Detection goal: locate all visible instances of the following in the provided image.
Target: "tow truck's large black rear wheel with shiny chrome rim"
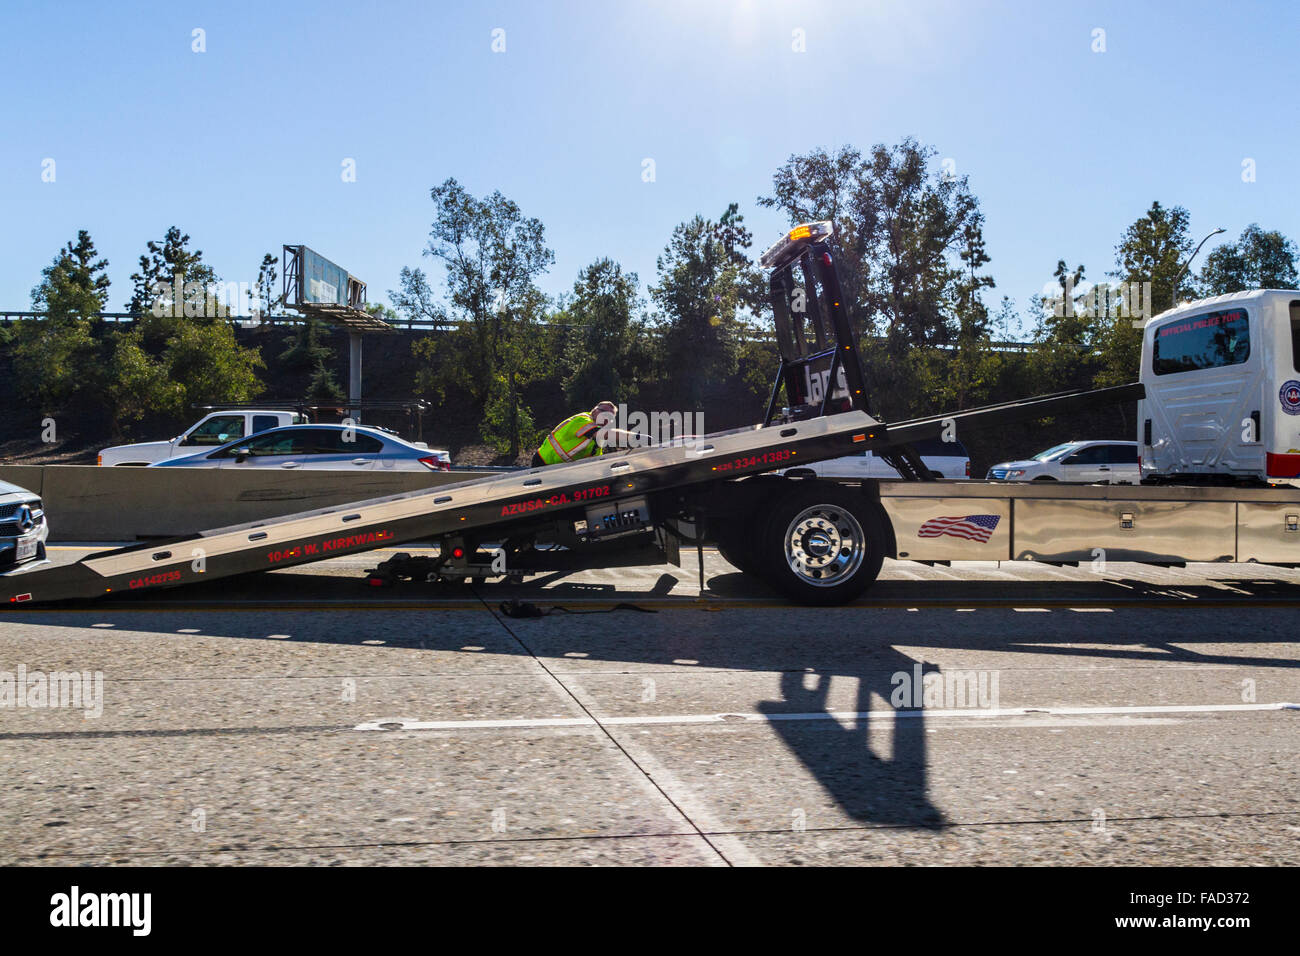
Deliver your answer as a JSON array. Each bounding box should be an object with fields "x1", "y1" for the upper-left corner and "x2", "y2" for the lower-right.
[{"x1": 754, "y1": 483, "x2": 887, "y2": 606}]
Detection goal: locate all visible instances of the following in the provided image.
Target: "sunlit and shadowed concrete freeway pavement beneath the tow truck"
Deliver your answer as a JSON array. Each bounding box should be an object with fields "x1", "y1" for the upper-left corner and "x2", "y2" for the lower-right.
[{"x1": 0, "y1": 550, "x2": 1300, "y2": 865}]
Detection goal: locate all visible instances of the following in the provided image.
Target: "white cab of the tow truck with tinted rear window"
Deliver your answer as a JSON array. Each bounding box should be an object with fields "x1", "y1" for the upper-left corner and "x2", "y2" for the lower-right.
[{"x1": 1138, "y1": 290, "x2": 1300, "y2": 480}]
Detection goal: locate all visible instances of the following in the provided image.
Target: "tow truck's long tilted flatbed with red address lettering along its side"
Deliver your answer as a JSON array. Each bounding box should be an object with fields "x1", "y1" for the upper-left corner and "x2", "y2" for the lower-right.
[{"x1": 0, "y1": 385, "x2": 1140, "y2": 605}]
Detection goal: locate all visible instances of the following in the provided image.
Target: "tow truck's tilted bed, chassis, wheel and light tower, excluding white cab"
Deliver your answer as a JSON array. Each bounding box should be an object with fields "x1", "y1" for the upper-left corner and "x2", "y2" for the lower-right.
[{"x1": 0, "y1": 222, "x2": 1300, "y2": 605}]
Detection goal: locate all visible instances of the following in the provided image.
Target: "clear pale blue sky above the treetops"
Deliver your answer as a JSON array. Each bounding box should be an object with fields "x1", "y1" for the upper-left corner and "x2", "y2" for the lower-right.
[{"x1": 0, "y1": 0, "x2": 1300, "y2": 335}]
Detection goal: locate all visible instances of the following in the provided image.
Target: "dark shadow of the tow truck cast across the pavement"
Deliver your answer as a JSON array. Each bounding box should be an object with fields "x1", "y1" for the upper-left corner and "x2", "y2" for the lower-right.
[{"x1": 0, "y1": 574, "x2": 1300, "y2": 827}]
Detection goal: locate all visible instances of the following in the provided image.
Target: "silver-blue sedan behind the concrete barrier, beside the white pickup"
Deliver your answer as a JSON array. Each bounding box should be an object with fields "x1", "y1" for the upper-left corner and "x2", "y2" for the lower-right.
[{"x1": 150, "y1": 425, "x2": 451, "y2": 471}]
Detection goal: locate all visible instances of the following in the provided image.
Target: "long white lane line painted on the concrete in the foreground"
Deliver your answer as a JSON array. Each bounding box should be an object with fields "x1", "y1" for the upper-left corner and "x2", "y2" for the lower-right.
[{"x1": 352, "y1": 702, "x2": 1300, "y2": 731}]
